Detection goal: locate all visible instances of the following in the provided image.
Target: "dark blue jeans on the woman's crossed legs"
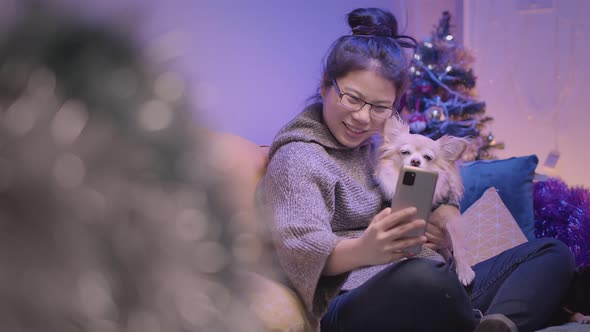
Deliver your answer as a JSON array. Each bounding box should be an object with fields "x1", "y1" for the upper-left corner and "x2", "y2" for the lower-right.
[{"x1": 321, "y1": 238, "x2": 575, "y2": 332}]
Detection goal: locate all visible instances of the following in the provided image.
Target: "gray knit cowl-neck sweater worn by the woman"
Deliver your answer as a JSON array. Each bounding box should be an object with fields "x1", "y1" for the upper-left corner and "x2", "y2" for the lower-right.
[{"x1": 258, "y1": 104, "x2": 442, "y2": 320}]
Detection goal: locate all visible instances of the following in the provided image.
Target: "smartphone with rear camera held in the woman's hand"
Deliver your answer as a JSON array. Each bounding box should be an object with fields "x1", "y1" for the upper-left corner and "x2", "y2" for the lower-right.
[{"x1": 391, "y1": 166, "x2": 438, "y2": 254}]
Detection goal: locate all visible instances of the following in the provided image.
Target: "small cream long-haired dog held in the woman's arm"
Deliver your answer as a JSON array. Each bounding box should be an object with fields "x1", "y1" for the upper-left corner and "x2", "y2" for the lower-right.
[{"x1": 375, "y1": 117, "x2": 475, "y2": 286}]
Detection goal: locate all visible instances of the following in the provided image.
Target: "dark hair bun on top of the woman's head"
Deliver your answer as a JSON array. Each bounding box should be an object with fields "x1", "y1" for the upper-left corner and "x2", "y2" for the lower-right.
[{"x1": 348, "y1": 8, "x2": 397, "y2": 37}]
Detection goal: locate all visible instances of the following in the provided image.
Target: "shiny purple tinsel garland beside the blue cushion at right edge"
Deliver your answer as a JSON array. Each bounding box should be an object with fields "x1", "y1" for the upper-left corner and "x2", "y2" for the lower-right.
[{"x1": 533, "y1": 178, "x2": 590, "y2": 266}]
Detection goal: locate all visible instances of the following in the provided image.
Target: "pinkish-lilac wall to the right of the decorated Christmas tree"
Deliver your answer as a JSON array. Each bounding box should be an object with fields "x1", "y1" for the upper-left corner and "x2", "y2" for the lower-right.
[{"x1": 464, "y1": 0, "x2": 590, "y2": 186}]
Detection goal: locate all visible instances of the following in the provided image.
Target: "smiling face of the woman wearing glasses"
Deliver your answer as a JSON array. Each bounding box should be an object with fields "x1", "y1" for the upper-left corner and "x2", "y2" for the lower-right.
[{"x1": 322, "y1": 70, "x2": 396, "y2": 148}]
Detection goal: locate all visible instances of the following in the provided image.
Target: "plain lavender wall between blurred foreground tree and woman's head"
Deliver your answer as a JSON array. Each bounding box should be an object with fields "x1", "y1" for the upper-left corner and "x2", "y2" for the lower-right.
[{"x1": 0, "y1": 0, "x2": 459, "y2": 144}]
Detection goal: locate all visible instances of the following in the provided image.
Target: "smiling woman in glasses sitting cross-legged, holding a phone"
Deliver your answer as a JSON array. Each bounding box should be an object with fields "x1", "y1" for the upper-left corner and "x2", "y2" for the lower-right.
[{"x1": 259, "y1": 8, "x2": 573, "y2": 332}]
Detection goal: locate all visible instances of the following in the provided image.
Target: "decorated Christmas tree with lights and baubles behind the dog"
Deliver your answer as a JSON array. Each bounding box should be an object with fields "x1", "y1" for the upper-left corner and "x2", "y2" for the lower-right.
[{"x1": 402, "y1": 11, "x2": 504, "y2": 160}]
